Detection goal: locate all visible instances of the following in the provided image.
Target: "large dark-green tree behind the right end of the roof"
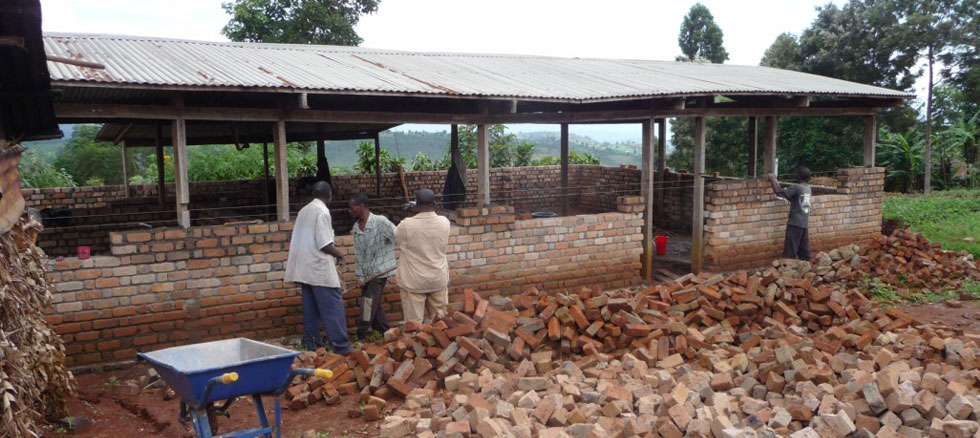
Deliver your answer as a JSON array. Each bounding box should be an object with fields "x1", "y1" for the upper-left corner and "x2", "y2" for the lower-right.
[{"x1": 760, "y1": 0, "x2": 918, "y2": 176}]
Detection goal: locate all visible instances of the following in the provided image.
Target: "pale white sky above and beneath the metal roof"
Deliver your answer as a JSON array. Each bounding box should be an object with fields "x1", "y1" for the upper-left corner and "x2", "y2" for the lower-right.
[{"x1": 41, "y1": 0, "x2": 843, "y2": 142}]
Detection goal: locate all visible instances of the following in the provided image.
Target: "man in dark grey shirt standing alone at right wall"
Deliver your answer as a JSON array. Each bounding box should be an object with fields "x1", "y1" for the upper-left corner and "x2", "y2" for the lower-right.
[{"x1": 769, "y1": 167, "x2": 812, "y2": 260}]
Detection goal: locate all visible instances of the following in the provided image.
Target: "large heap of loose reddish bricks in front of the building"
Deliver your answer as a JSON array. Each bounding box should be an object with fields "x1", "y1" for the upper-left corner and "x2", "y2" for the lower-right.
[{"x1": 289, "y1": 232, "x2": 980, "y2": 438}]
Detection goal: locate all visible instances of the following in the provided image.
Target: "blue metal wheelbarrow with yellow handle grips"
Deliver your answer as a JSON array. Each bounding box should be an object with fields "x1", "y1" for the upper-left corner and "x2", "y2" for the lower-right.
[{"x1": 138, "y1": 338, "x2": 333, "y2": 438}]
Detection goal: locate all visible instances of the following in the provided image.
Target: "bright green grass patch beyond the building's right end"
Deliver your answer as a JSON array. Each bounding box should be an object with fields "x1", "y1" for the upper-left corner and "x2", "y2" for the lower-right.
[{"x1": 882, "y1": 190, "x2": 980, "y2": 258}]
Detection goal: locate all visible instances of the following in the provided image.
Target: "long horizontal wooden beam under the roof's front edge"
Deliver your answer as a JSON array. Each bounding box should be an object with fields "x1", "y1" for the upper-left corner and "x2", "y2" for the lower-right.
[{"x1": 55, "y1": 103, "x2": 875, "y2": 125}]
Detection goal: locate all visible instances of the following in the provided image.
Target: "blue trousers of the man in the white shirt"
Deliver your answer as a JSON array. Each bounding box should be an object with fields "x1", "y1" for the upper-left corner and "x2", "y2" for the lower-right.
[{"x1": 300, "y1": 283, "x2": 352, "y2": 354}]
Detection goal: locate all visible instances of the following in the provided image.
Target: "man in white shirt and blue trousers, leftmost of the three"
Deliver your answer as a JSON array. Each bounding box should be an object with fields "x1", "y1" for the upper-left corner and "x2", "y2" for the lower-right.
[{"x1": 285, "y1": 181, "x2": 351, "y2": 354}]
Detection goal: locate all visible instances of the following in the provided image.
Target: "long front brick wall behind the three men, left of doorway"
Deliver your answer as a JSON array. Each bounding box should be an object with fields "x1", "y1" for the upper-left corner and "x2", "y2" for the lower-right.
[{"x1": 47, "y1": 197, "x2": 642, "y2": 366}]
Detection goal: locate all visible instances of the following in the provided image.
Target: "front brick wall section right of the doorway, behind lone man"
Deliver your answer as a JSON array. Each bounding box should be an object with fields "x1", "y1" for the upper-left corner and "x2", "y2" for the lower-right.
[{"x1": 704, "y1": 167, "x2": 885, "y2": 271}]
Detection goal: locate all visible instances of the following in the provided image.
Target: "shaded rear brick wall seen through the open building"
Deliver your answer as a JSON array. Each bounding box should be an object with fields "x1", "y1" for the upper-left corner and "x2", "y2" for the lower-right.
[{"x1": 24, "y1": 165, "x2": 644, "y2": 256}]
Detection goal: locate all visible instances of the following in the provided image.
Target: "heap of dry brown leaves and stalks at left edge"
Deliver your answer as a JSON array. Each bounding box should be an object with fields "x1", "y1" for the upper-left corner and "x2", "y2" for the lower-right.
[{"x1": 0, "y1": 216, "x2": 72, "y2": 437}]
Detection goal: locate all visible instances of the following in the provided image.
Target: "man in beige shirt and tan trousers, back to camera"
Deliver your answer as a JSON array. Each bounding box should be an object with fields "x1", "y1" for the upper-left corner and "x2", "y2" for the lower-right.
[{"x1": 395, "y1": 189, "x2": 450, "y2": 323}]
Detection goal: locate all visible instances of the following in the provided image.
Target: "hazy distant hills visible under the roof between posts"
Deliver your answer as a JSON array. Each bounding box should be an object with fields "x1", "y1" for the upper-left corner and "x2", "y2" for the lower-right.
[{"x1": 327, "y1": 131, "x2": 640, "y2": 167}]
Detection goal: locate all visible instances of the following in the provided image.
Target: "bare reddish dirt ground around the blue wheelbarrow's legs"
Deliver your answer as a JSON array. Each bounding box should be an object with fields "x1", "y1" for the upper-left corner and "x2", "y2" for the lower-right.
[{"x1": 42, "y1": 365, "x2": 393, "y2": 438}]
